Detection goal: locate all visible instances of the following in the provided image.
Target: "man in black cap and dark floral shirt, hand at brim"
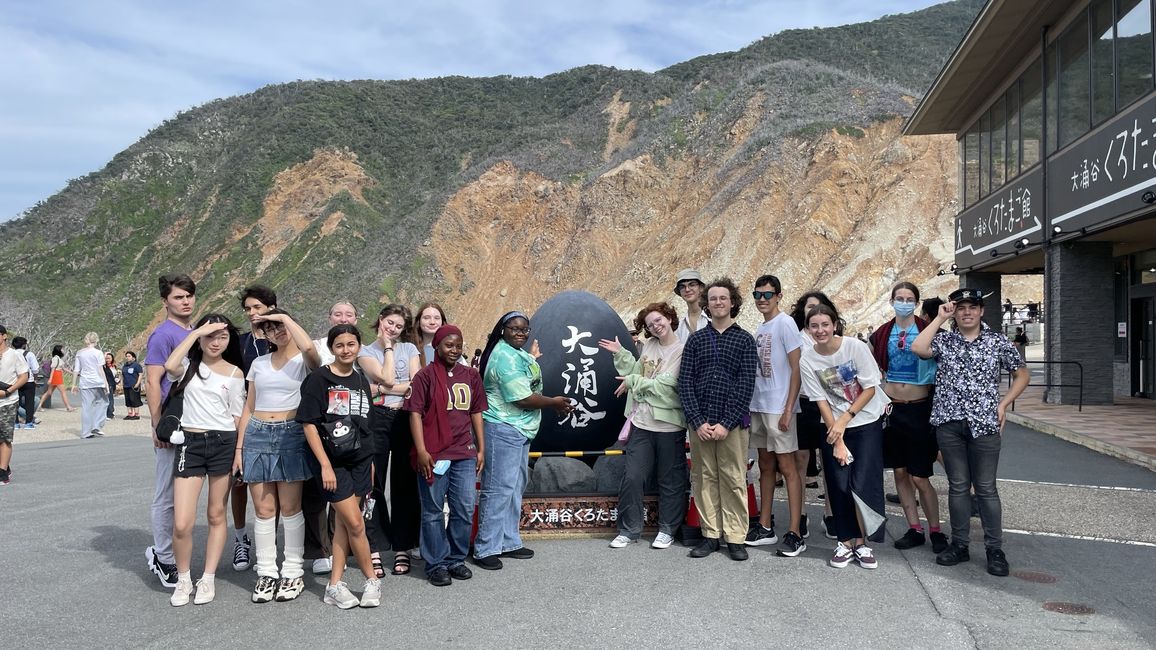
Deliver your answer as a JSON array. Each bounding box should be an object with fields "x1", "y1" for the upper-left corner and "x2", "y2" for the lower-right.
[{"x1": 911, "y1": 289, "x2": 1031, "y2": 576}]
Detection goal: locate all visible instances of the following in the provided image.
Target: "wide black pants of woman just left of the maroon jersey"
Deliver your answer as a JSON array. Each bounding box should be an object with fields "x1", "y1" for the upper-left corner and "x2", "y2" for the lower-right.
[{"x1": 365, "y1": 406, "x2": 422, "y2": 553}]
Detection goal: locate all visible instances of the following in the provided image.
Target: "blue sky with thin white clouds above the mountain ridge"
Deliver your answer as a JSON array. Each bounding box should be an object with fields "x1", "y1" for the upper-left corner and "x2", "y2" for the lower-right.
[{"x1": 0, "y1": 0, "x2": 936, "y2": 221}]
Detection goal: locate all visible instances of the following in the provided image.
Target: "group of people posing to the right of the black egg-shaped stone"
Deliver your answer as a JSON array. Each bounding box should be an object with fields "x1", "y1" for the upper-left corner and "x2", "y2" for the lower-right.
[{"x1": 600, "y1": 269, "x2": 1030, "y2": 576}]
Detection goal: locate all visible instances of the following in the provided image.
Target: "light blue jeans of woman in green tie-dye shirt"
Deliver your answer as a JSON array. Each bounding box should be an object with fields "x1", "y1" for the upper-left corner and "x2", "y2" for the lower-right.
[{"x1": 471, "y1": 421, "x2": 529, "y2": 559}]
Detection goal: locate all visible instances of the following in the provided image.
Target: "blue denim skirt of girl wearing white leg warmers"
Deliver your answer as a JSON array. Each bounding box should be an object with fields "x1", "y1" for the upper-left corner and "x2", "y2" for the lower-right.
[{"x1": 240, "y1": 418, "x2": 313, "y2": 483}]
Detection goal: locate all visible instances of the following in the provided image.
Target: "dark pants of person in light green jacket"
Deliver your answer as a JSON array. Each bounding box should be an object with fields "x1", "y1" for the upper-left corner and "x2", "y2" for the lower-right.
[{"x1": 618, "y1": 424, "x2": 689, "y2": 539}]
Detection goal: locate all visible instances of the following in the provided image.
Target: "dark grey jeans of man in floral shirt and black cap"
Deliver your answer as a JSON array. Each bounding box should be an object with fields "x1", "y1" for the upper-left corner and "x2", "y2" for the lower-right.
[{"x1": 935, "y1": 420, "x2": 1003, "y2": 548}]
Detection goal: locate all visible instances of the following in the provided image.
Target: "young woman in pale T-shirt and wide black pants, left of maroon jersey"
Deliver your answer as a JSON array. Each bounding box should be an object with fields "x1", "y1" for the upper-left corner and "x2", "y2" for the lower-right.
[{"x1": 357, "y1": 304, "x2": 425, "y2": 577}]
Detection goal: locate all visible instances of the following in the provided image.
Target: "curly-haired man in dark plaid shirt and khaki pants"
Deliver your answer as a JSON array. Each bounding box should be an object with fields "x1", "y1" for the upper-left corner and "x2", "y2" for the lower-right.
[{"x1": 679, "y1": 278, "x2": 758, "y2": 561}]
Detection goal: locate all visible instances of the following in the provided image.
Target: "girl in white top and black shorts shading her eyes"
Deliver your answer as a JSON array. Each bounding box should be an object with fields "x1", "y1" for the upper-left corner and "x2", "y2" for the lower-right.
[{"x1": 164, "y1": 313, "x2": 245, "y2": 606}]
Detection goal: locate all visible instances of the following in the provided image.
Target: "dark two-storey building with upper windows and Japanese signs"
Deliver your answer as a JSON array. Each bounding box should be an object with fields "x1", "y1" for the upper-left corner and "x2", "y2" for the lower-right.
[{"x1": 905, "y1": 0, "x2": 1156, "y2": 404}]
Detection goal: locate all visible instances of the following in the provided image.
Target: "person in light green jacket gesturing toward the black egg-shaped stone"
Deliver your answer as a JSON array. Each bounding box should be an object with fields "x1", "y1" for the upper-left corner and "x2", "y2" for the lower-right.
[{"x1": 598, "y1": 303, "x2": 689, "y2": 548}]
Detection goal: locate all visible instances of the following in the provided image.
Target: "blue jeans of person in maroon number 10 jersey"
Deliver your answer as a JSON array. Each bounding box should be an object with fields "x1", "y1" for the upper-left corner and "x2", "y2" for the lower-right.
[{"x1": 417, "y1": 458, "x2": 477, "y2": 575}]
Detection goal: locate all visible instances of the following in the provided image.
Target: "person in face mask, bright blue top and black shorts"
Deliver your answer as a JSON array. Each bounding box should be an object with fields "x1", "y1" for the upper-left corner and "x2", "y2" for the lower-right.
[{"x1": 870, "y1": 282, "x2": 947, "y2": 553}]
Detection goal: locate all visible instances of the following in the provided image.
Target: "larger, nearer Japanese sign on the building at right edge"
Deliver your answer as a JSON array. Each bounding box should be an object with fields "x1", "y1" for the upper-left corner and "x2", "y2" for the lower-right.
[{"x1": 1047, "y1": 91, "x2": 1156, "y2": 232}]
